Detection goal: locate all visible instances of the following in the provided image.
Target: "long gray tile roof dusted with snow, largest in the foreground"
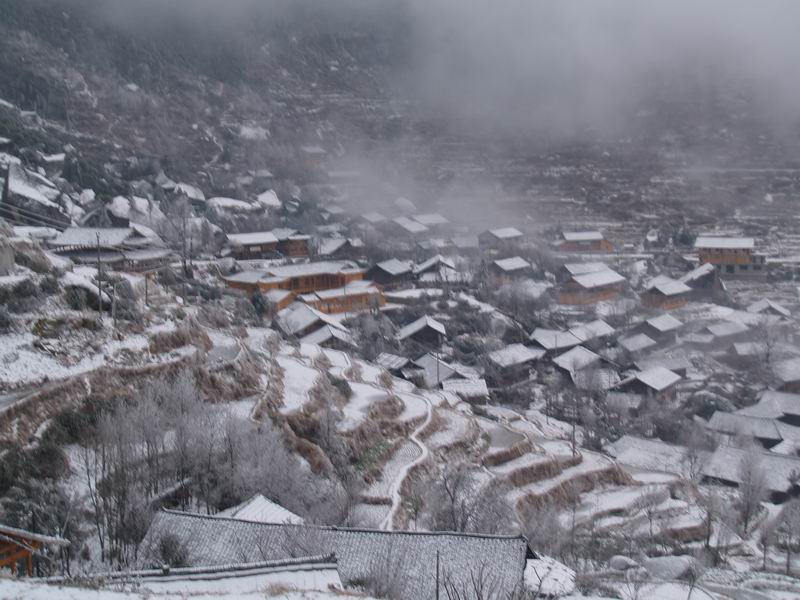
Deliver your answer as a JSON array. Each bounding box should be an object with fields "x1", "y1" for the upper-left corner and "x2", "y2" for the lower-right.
[{"x1": 141, "y1": 510, "x2": 529, "y2": 600}]
